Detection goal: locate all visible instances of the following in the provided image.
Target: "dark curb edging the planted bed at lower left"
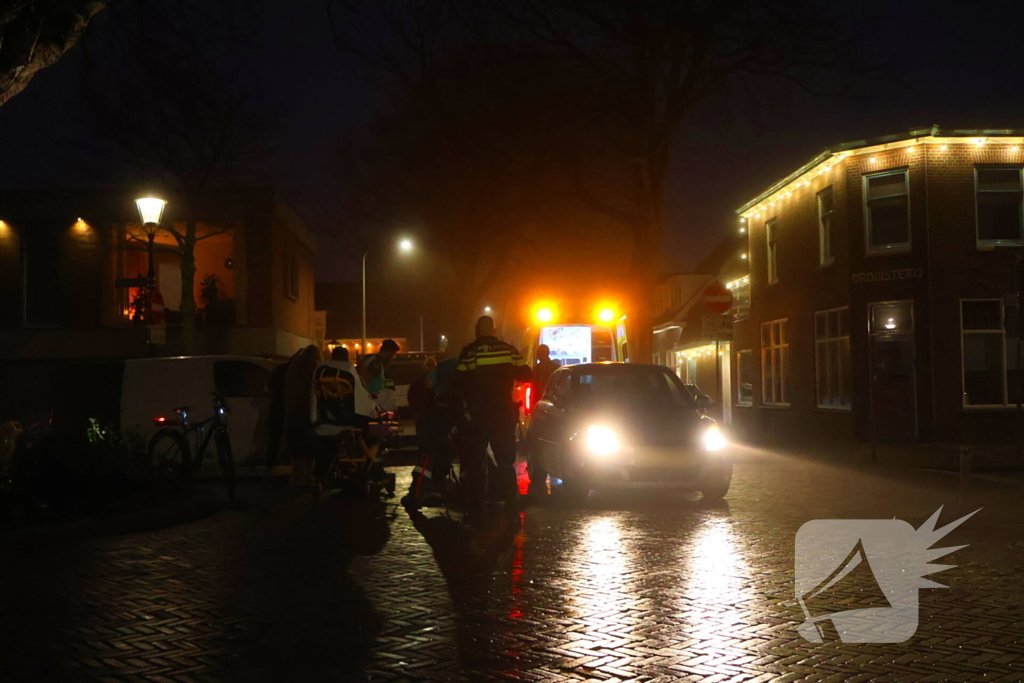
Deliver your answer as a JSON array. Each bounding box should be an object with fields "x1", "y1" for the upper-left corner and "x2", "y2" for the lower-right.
[{"x1": 0, "y1": 488, "x2": 222, "y2": 548}]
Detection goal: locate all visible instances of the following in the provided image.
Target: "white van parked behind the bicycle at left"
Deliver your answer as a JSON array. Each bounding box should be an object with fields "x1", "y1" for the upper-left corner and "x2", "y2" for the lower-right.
[{"x1": 120, "y1": 355, "x2": 274, "y2": 467}]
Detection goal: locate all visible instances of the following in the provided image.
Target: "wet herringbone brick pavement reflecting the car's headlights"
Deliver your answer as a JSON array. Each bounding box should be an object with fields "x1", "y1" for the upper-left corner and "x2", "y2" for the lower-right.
[{"x1": 0, "y1": 450, "x2": 1024, "y2": 681}]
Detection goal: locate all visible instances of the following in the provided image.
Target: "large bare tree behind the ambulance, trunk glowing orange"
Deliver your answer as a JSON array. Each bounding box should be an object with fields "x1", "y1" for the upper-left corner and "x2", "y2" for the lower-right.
[{"x1": 330, "y1": 0, "x2": 863, "y2": 359}]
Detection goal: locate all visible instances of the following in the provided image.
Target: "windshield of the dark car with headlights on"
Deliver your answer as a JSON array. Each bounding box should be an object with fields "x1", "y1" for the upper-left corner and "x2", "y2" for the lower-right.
[{"x1": 572, "y1": 366, "x2": 694, "y2": 410}]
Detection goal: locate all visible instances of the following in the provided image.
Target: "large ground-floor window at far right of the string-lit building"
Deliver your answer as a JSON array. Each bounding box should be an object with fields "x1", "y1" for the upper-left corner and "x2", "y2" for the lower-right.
[{"x1": 961, "y1": 299, "x2": 1020, "y2": 407}]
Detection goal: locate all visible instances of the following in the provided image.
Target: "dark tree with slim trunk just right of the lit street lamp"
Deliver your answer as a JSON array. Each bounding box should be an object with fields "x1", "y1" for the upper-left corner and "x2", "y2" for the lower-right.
[{"x1": 77, "y1": 0, "x2": 272, "y2": 348}]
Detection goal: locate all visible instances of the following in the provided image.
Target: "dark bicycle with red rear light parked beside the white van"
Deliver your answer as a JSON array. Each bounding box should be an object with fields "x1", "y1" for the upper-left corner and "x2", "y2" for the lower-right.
[{"x1": 147, "y1": 391, "x2": 234, "y2": 500}]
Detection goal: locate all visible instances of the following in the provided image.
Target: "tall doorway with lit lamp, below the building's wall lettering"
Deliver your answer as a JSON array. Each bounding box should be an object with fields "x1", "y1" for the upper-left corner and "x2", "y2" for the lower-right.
[{"x1": 868, "y1": 301, "x2": 918, "y2": 441}]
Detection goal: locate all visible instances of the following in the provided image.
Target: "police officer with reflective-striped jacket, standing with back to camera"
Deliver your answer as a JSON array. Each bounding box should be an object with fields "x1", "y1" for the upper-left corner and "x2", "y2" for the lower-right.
[{"x1": 455, "y1": 315, "x2": 531, "y2": 515}]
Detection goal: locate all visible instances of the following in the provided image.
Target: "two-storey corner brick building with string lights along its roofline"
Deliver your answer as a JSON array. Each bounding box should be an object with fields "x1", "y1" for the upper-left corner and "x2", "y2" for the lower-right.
[{"x1": 732, "y1": 127, "x2": 1024, "y2": 442}]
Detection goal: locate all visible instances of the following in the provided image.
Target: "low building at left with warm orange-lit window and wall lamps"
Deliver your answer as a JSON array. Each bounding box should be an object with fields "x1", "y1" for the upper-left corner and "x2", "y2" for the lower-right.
[{"x1": 0, "y1": 187, "x2": 316, "y2": 358}]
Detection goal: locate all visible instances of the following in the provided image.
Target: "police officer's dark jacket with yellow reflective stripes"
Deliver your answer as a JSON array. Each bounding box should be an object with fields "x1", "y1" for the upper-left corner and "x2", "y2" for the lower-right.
[{"x1": 455, "y1": 337, "x2": 531, "y2": 414}]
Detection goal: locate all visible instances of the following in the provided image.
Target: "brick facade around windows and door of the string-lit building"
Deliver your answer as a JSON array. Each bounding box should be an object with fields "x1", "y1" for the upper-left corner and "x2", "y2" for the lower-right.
[{"x1": 733, "y1": 143, "x2": 1024, "y2": 442}]
